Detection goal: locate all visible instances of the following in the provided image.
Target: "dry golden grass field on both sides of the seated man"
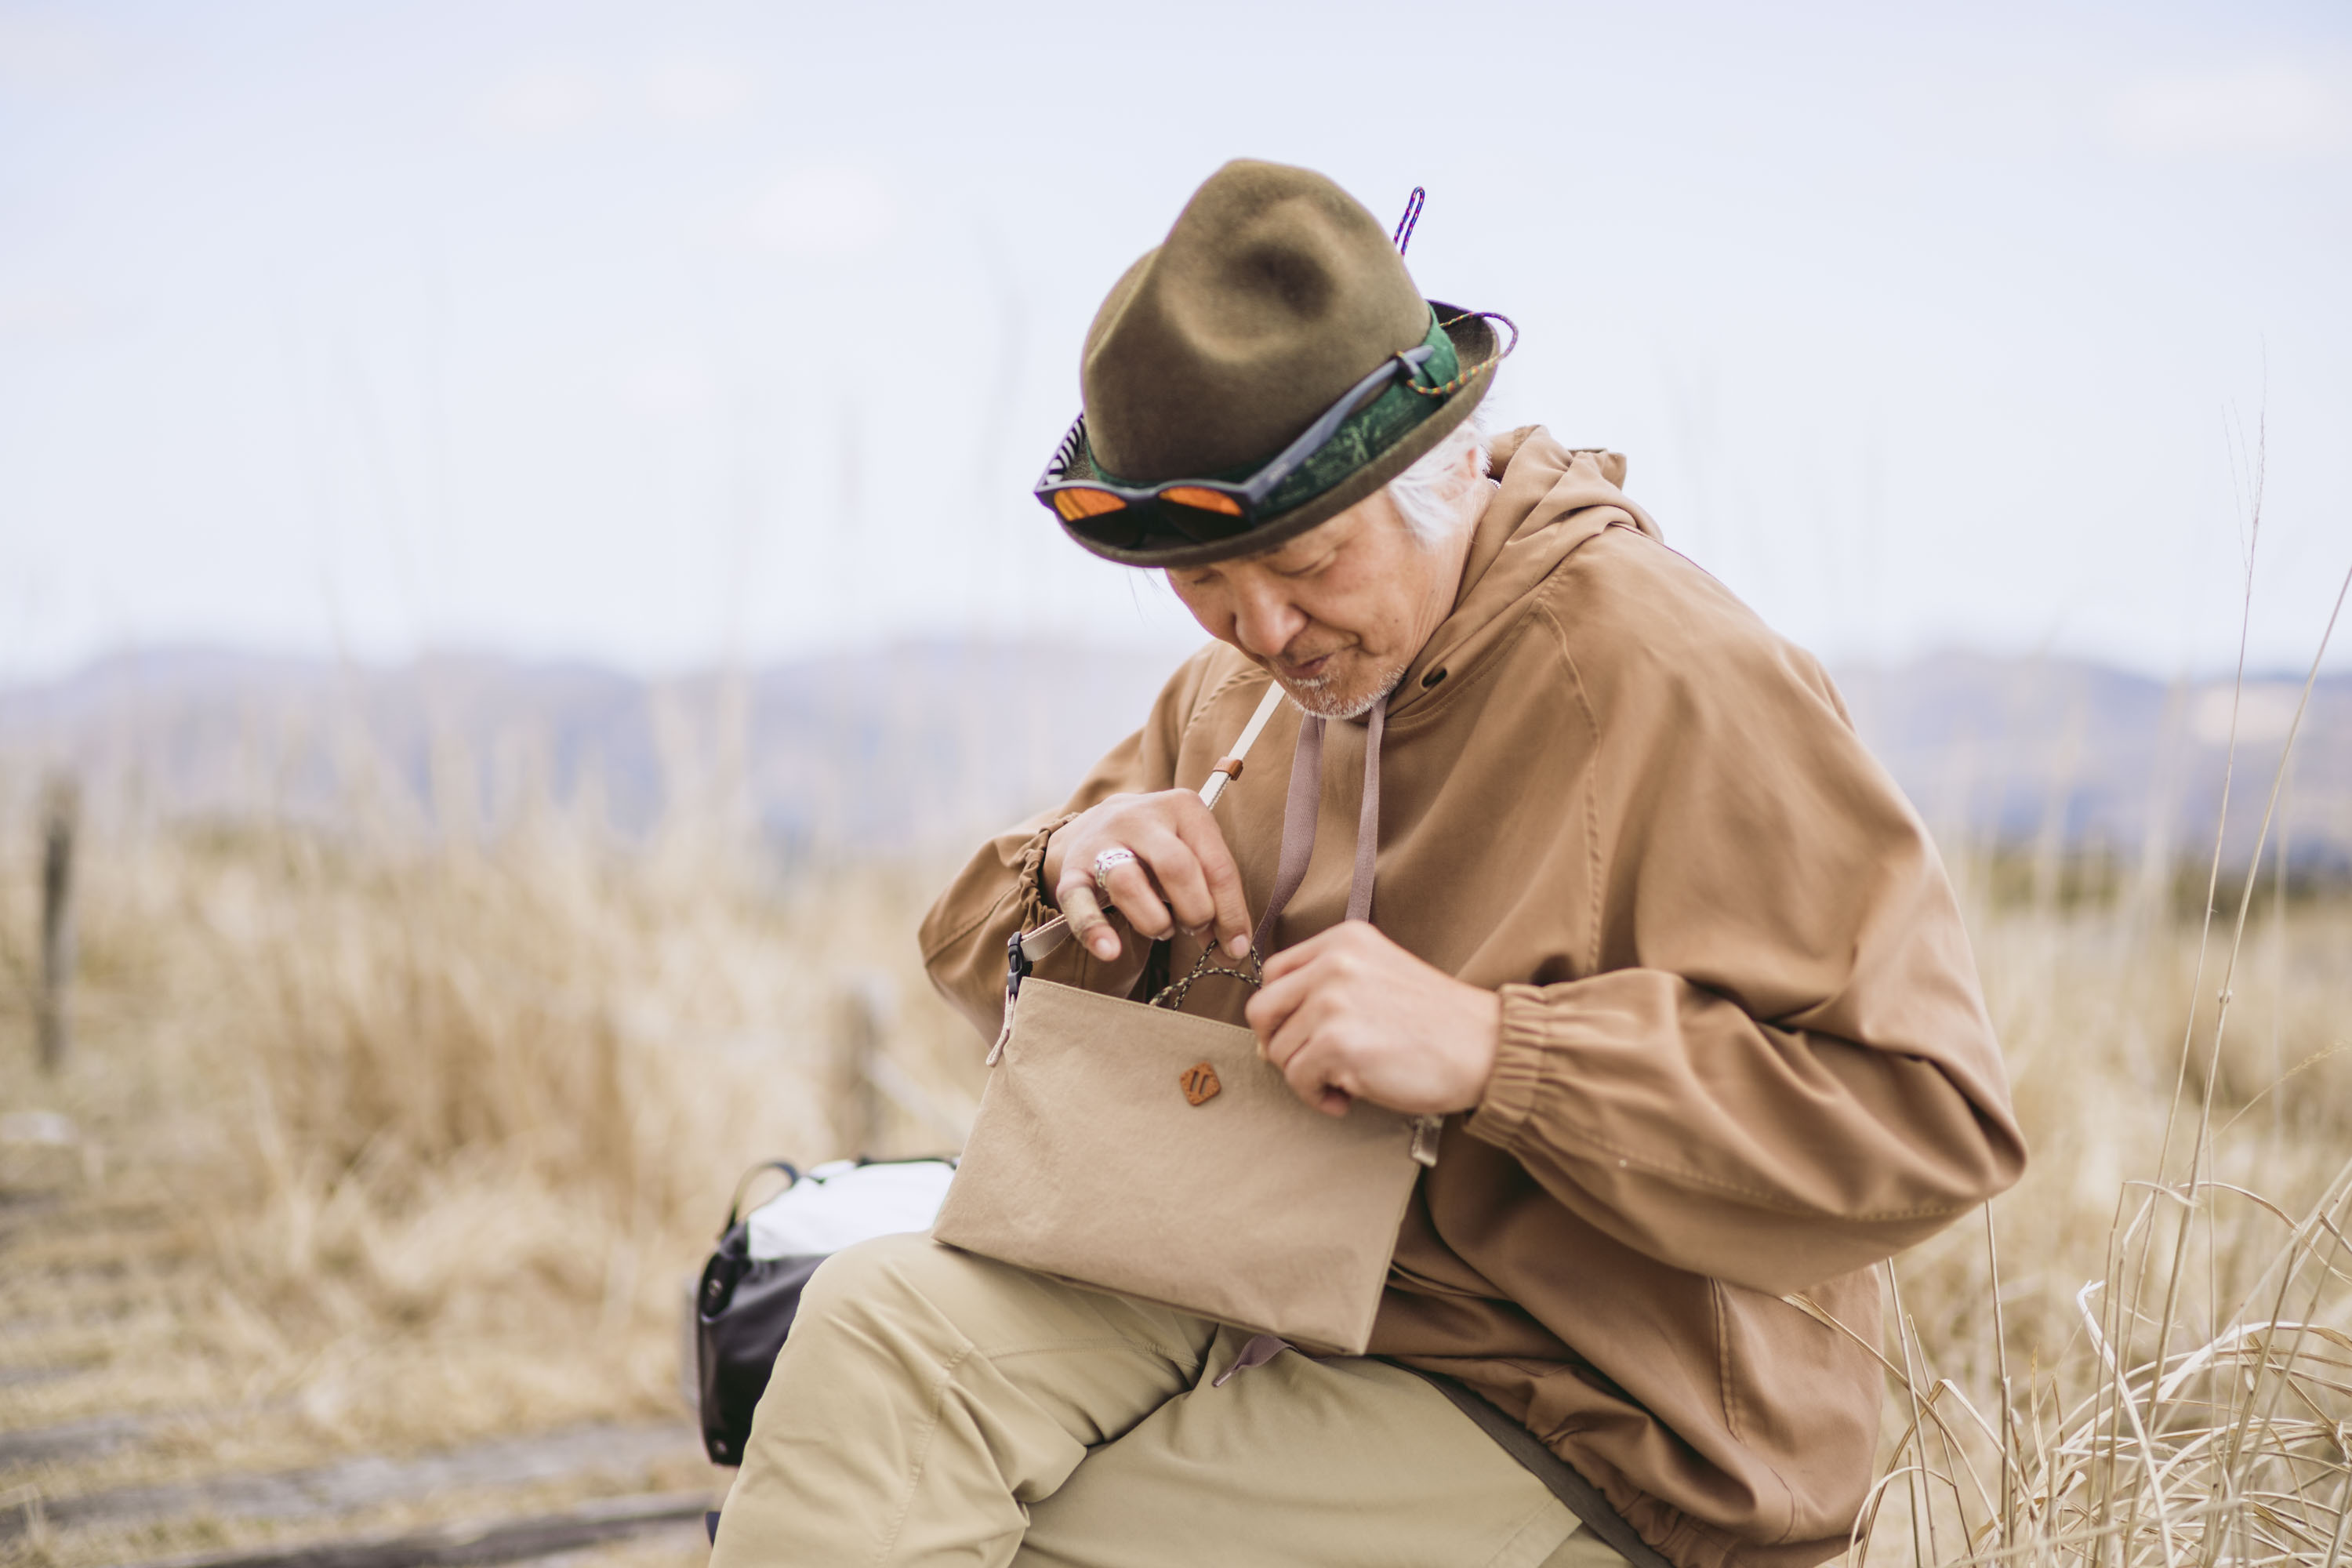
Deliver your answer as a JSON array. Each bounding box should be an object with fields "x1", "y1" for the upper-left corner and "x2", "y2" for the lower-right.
[{"x1": 0, "y1": 738, "x2": 2352, "y2": 1568}]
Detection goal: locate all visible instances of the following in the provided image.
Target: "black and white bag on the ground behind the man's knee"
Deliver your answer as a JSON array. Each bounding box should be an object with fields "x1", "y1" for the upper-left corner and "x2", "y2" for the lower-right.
[{"x1": 694, "y1": 1159, "x2": 955, "y2": 1465}]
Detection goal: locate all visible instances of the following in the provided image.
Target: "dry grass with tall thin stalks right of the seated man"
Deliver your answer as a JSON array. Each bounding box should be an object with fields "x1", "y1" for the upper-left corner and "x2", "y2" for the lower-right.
[{"x1": 1856, "y1": 533, "x2": 2352, "y2": 1568}]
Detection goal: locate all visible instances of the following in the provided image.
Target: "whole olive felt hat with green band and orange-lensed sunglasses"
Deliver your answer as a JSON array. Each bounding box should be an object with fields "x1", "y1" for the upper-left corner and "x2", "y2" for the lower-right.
[{"x1": 1037, "y1": 160, "x2": 1508, "y2": 567}]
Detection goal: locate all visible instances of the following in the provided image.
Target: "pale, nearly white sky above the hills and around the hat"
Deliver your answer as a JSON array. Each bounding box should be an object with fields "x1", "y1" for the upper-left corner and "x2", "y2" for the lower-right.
[{"x1": 0, "y1": 0, "x2": 2352, "y2": 682}]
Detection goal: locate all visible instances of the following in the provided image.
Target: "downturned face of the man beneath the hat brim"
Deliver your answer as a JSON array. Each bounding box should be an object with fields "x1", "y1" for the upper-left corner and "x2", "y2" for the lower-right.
[{"x1": 1169, "y1": 492, "x2": 1470, "y2": 720}]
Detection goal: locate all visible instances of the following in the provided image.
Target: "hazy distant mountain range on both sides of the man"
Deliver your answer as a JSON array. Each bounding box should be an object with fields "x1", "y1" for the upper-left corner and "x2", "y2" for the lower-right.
[{"x1": 0, "y1": 642, "x2": 2352, "y2": 869}]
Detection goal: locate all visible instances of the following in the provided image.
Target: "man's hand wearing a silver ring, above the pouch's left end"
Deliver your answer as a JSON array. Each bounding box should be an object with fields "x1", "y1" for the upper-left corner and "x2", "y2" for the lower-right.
[{"x1": 1042, "y1": 789, "x2": 1249, "y2": 961}]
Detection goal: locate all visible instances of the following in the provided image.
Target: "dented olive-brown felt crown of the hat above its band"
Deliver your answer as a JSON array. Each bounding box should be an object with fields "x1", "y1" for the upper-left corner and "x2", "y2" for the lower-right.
[{"x1": 1080, "y1": 160, "x2": 1430, "y2": 485}]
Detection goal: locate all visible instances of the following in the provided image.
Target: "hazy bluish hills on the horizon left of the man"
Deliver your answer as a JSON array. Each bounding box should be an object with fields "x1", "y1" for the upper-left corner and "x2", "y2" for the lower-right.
[{"x1": 0, "y1": 642, "x2": 1169, "y2": 862}]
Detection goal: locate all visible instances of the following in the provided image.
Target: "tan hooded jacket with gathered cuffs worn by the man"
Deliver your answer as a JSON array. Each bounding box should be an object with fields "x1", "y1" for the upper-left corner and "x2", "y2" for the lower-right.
[{"x1": 922, "y1": 428, "x2": 2025, "y2": 1568}]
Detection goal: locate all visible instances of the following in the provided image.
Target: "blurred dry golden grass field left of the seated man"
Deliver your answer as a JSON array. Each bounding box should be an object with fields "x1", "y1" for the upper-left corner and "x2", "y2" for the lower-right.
[{"x1": 0, "y1": 820, "x2": 978, "y2": 1563}]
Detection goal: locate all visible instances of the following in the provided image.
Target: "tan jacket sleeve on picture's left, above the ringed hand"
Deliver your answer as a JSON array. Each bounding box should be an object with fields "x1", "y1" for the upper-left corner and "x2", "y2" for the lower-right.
[{"x1": 920, "y1": 647, "x2": 1216, "y2": 1039}]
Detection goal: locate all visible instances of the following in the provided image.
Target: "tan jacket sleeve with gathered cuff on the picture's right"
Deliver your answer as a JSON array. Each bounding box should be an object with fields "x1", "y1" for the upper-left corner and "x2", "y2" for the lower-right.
[{"x1": 1468, "y1": 583, "x2": 2025, "y2": 1293}]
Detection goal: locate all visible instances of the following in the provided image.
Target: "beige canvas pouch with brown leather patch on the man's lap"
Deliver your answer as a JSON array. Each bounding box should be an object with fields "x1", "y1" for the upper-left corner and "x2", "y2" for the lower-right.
[{"x1": 931, "y1": 687, "x2": 1439, "y2": 1354}]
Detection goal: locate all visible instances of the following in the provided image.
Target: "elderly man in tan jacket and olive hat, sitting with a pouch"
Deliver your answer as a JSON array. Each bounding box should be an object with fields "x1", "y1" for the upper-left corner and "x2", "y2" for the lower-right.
[{"x1": 715, "y1": 162, "x2": 2025, "y2": 1568}]
